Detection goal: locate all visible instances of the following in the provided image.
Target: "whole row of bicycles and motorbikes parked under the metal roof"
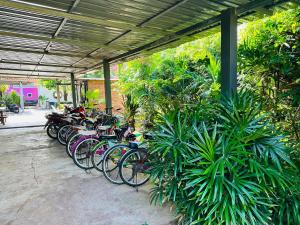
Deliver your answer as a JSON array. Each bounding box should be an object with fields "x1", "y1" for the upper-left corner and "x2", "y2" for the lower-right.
[{"x1": 45, "y1": 106, "x2": 151, "y2": 187}]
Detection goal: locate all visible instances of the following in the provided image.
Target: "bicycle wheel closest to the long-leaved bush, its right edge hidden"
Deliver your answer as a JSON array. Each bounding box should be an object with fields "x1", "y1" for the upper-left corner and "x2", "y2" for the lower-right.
[{"x1": 119, "y1": 149, "x2": 150, "y2": 187}]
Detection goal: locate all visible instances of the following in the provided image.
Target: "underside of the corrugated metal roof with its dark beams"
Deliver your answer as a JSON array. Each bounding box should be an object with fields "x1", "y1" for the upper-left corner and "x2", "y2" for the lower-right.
[{"x1": 0, "y1": 0, "x2": 299, "y2": 79}]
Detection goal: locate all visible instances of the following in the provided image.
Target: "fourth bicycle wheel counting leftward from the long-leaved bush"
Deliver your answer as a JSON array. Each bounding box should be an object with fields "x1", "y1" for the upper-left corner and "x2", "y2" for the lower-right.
[{"x1": 72, "y1": 138, "x2": 100, "y2": 169}]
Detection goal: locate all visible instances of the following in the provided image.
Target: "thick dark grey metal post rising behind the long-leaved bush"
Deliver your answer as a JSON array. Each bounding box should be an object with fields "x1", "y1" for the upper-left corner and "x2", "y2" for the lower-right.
[{"x1": 221, "y1": 8, "x2": 237, "y2": 97}]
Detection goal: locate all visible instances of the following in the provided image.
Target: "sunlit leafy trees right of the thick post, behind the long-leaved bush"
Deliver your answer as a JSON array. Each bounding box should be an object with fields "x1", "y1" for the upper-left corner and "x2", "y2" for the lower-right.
[{"x1": 239, "y1": 8, "x2": 300, "y2": 168}]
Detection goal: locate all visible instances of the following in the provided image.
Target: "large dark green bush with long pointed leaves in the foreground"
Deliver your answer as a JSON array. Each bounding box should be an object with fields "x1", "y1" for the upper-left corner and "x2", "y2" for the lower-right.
[{"x1": 151, "y1": 91, "x2": 300, "y2": 225}]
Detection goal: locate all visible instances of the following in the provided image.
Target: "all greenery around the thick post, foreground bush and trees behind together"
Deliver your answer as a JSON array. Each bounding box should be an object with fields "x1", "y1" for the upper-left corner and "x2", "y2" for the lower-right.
[{"x1": 113, "y1": 8, "x2": 300, "y2": 225}]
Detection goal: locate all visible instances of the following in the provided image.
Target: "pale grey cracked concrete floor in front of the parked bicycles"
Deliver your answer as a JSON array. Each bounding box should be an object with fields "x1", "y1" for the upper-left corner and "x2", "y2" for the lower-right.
[{"x1": 0, "y1": 128, "x2": 174, "y2": 225}]
